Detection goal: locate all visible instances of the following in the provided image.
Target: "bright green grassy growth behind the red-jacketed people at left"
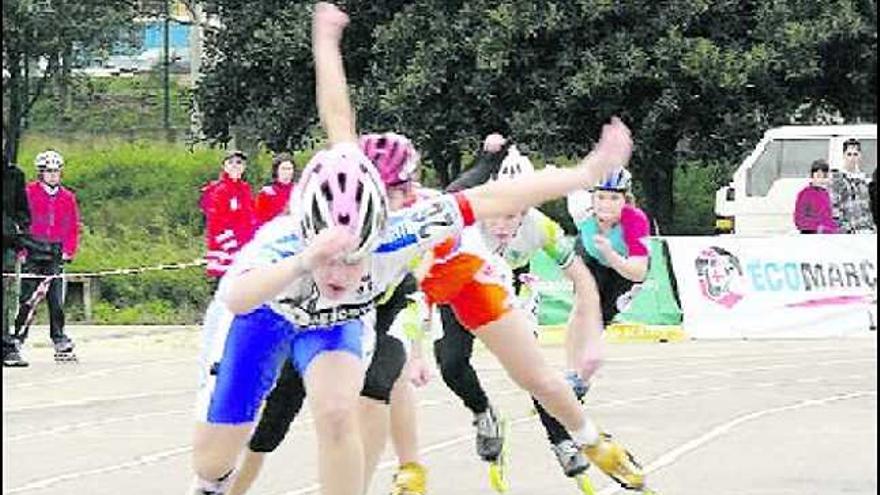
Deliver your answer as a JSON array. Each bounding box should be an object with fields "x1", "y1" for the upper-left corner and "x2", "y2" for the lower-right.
[{"x1": 20, "y1": 135, "x2": 268, "y2": 324}]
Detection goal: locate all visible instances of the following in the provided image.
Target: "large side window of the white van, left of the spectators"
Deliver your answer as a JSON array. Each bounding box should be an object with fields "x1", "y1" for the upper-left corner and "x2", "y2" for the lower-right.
[{"x1": 746, "y1": 139, "x2": 828, "y2": 196}]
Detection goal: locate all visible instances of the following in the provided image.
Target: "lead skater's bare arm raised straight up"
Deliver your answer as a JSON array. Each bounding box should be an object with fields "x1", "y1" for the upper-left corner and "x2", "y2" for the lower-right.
[{"x1": 312, "y1": 2, "x2": 357, "y2": 146}]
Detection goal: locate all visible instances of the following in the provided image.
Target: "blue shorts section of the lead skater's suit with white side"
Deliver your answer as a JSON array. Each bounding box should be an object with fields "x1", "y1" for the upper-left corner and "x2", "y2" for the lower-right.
[{"x1": 197, "y1": 306, "x2": 364, "y2": 424}]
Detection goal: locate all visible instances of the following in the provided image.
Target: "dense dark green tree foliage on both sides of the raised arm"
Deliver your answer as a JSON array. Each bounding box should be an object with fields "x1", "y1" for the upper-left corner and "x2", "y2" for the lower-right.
[{"x1": 197, "y1": 0, "x2": 877, "y2": 229}]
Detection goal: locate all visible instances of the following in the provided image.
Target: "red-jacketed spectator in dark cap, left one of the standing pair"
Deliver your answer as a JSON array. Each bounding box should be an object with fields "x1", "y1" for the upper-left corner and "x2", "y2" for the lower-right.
[{"x1": 200, "y1": 150, "x2": 256, "y2": 280}]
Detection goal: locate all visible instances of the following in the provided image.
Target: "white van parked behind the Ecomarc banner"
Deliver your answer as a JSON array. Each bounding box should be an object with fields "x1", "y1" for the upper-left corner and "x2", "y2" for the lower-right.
[{"x1": 715, "y1": 124, "x2": 877, "y2": 236}]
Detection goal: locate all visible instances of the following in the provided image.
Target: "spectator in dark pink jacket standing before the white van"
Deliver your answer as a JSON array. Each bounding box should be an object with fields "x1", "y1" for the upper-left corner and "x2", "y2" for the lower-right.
[{"x1": 794, "y1": 159, "x2": 840, "y2": 234}]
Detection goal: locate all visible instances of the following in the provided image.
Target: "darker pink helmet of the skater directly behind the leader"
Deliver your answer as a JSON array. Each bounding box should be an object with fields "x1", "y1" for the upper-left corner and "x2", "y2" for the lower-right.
[{"x1": 360, "y1": 132, "x2": 419, "y2": 186}]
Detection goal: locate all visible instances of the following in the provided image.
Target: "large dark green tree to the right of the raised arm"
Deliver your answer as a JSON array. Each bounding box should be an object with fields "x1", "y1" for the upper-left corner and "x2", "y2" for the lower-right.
[{"x1": 361, "y1": 0, "x2": 876, "y2": 229}]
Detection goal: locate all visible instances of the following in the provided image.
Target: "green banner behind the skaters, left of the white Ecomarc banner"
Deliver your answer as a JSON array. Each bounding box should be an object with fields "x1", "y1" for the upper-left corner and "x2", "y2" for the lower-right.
[{"x1": 530, "y1": 239, "x2": 681, "y2": 325}]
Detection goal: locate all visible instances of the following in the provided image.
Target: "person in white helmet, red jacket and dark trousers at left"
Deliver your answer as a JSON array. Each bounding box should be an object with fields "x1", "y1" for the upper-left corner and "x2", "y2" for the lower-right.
[{"x1": 15, "y1": 150, "x2": 79, "y2": 360}]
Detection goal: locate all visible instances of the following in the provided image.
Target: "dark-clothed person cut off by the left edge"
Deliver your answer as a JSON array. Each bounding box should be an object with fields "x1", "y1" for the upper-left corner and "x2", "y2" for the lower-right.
[{"x1": 3, "y1": 149, "x2": 31, "y2": 366}]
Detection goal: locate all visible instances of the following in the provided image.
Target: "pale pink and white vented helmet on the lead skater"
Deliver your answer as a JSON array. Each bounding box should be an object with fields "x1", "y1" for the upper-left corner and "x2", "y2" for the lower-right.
[{"x1": 290, "y1": 144, "x2": 388, "y2": 259}]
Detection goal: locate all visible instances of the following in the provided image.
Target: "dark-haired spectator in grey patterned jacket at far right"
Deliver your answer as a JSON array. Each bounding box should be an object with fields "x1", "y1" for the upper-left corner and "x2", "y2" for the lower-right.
[{"x1": 830, "y1": 139, "x2": 876, "y2": 234}]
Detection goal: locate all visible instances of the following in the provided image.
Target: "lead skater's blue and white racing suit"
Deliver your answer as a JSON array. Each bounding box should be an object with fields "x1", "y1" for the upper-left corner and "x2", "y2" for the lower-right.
[{"x1": 196, "y1": 195, "x2": 473, "y2": 424}]
